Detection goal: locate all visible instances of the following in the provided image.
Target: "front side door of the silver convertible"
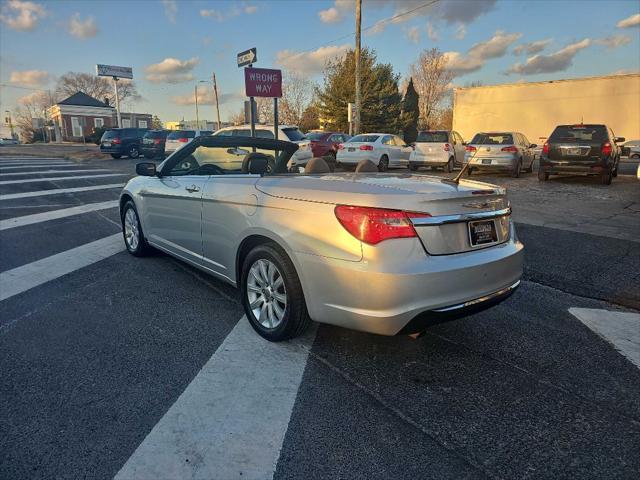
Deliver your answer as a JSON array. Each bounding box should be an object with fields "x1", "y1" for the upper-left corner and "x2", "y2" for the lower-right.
[{"x1": 141, "y1": 149, "x2": 209, "y2": 265}]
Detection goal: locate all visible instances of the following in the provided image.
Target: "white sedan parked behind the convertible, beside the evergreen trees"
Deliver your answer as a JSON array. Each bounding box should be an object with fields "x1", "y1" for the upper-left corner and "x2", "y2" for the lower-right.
[{"x1": 336, "y1": 133, "x2": 413, "y2": 172}]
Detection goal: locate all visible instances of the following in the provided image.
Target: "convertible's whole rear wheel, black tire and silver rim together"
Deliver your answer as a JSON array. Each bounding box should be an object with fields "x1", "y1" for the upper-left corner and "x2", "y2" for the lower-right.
[{"x1": 240, "y1": 243, "x2": 311, "y2": 342}]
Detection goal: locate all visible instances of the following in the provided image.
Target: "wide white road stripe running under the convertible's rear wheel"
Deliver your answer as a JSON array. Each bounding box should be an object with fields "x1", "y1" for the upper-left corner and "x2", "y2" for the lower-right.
[{"x1": 115, "y1": 317, "x2": 315, "y2": 480}]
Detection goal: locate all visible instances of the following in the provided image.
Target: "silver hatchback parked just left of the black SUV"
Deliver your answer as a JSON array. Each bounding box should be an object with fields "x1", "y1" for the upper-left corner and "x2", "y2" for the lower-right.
[{"x1": 465, "y1": 132, "x2": 537, "y2": 178}]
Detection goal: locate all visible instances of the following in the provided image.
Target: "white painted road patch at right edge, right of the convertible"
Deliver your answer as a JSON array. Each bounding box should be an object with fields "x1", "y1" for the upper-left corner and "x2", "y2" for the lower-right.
[{"x1": 569, "y1": 308, "x2": 640, "y2": 368}]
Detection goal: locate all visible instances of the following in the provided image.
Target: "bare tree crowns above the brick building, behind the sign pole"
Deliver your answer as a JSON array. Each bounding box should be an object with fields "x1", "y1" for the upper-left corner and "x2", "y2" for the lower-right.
[{"x1": 55, "y1": 72, "x2": 141, "y2": 105}]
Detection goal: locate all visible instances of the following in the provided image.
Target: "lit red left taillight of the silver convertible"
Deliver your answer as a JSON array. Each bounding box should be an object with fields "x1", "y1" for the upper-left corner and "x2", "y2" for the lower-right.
[{"x1": 335, "y1": 205, "x2": 431, "y2": 245}]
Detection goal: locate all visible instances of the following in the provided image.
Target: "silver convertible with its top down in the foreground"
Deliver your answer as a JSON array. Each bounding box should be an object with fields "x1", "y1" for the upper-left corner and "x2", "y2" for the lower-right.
[{"x1": 120, "y1": 137, "x2": 523, "y2": 341}]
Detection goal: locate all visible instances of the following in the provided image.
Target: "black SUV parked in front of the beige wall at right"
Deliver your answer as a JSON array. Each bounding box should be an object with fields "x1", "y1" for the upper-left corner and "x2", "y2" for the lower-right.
[{"x1": 538, "y1": 124, "x2": 624, "y2": 185}]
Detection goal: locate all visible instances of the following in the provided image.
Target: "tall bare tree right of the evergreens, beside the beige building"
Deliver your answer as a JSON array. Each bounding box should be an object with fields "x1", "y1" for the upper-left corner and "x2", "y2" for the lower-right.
[{"x1": 410, "y1": 48, "x2": 453, "y2": 128}]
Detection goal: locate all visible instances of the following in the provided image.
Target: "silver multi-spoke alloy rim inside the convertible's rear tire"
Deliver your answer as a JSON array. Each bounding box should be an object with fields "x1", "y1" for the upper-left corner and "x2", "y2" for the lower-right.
[{"x1": 246, "y1": 258, "x2": 287, "y2": 329}]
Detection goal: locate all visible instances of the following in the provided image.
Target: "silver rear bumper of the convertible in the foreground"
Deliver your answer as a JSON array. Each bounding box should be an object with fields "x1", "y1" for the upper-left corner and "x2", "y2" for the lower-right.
[{"x1": 298, "y1": 232, "x2": 523, "y2": 335}]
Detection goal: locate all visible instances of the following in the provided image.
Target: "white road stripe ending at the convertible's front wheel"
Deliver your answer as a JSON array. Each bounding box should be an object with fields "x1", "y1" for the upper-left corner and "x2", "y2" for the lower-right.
[{"x1": 0, "y1": 233, "x2": 124, "y2": 301}]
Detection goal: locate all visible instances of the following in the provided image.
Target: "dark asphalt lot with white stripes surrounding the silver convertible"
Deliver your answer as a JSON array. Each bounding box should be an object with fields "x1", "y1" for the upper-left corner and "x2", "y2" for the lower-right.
[{"x1": 0, "y1": 152, "x2": 640, "y2": 479}]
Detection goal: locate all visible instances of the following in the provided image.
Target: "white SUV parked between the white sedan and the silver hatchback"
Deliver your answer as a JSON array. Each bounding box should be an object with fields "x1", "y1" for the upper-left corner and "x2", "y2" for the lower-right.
[{"x1": 409, "y1": 130, "x2": 464, "y2": 172}]
